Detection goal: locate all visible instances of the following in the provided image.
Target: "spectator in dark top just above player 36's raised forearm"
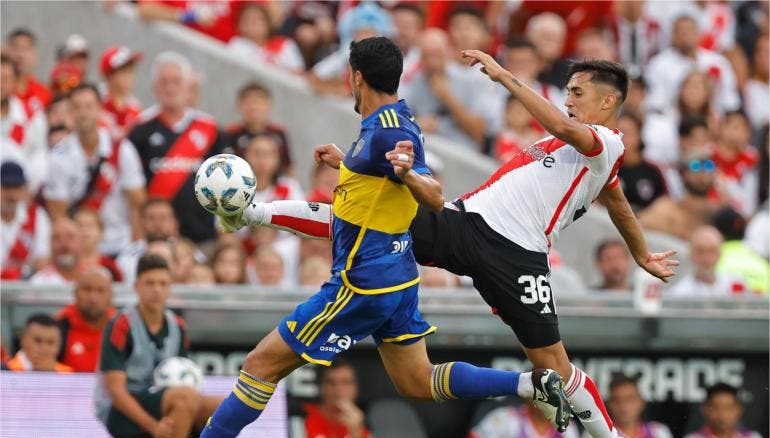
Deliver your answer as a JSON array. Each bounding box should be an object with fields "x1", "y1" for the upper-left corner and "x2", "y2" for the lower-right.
[{"x1": 524, "y1": 12, "x2": 569, "y2": 88}]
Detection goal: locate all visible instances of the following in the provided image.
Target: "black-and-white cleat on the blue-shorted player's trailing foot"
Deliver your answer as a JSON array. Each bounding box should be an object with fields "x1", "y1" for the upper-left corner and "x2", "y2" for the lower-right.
[{"x1": 532, "y1": 368, "x2": 572, "y2": 432}]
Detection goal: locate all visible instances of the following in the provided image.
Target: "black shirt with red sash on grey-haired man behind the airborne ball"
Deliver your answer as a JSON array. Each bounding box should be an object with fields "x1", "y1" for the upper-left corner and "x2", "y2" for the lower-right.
[{"x1": 127, "y1": 107, "x2": 224, "y2": 242}]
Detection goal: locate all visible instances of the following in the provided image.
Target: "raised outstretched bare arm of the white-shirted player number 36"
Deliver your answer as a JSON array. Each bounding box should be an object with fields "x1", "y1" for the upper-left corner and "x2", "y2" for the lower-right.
[{"x1": 461, "y1": 50, "x2": 596, "y2": 154}]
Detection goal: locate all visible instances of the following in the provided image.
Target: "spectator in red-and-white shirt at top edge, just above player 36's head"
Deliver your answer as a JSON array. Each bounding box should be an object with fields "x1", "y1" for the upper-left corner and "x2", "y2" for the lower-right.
[{"x1": 609, "y1": 1, "x2": 661, "y2": 78}]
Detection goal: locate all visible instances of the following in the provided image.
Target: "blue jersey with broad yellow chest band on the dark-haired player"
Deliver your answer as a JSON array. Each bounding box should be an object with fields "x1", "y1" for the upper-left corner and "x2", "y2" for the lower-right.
[{"x1": 332, "y1": 100, "x2": 430, "y2": 294}]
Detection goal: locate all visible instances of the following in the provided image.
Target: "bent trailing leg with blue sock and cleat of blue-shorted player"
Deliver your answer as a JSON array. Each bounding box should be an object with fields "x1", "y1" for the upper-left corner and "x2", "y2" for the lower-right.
[{"x1": 379, "y1": 339, "x2": 571, "y2": 432}]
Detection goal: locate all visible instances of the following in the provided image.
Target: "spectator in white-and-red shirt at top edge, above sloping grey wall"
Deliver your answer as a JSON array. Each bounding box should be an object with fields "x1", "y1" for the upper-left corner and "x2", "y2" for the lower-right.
[{"x1": 227, "y1": 3, "x2": 305, "y2": 73}]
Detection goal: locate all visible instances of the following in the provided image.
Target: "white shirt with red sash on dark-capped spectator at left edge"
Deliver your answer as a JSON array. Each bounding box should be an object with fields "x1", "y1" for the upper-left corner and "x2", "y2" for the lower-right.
[{"x1": 0, "y1": 203, "x2": 51, "y2": 280}]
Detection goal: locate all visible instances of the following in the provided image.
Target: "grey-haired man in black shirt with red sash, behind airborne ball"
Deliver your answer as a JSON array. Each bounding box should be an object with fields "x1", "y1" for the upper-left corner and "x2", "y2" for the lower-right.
[{"x1": 127, "y1": 52, "x2": 224, "y2": 244}]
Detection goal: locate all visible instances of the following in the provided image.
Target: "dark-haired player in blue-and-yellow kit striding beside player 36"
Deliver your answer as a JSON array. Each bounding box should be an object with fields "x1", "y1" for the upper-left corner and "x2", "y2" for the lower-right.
[{"x1": 201, "y1": 37, "x2": 571, "y2": 438}]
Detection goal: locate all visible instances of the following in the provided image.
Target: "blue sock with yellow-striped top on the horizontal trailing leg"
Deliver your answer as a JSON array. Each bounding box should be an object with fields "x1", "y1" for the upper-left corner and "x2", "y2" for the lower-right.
[{"x1": 431, "y1": 362, "x2": 521, "y2": 401}]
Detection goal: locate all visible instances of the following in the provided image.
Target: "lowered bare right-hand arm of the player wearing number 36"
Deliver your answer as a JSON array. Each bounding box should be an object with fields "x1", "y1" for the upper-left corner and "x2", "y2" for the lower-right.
[{"x1": 599, "y1": 184, "x2": 679, "y2": 282}]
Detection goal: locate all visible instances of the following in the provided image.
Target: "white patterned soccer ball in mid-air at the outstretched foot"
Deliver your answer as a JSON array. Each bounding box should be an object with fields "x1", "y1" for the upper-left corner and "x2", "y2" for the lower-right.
[{"x1": 195, "y1": 154, "x2": 256, "y2": 216}]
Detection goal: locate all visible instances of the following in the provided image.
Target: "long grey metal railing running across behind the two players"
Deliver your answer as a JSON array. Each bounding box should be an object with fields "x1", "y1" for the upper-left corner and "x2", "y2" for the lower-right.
[{"x1": 0, "y1": 282, "x2": 770, "y2": 353}]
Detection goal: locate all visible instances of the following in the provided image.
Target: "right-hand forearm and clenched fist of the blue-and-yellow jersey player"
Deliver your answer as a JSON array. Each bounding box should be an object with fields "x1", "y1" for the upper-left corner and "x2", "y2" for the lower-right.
[{"x1": 385, "y1": 140, "x2": 444, "y2": 211}]
